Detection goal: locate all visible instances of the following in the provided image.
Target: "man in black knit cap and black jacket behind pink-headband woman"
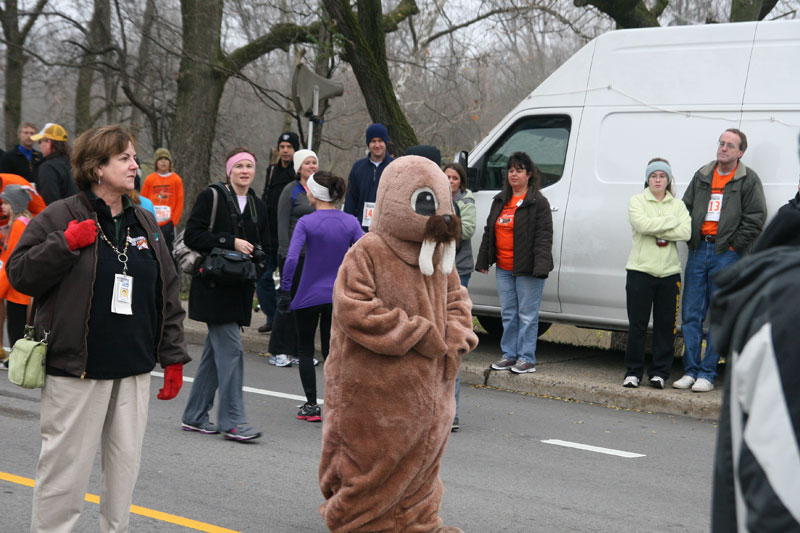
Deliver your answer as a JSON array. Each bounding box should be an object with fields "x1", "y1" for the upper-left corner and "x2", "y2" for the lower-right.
[{"x1": 256, "y1": 131, "x2": 300, "y2": 333}]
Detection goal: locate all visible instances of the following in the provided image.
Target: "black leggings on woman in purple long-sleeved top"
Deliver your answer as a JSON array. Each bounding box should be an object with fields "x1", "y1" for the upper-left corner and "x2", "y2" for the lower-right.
[{"x1": 294, "y1": 304, "x2": 333, "y2": 404}]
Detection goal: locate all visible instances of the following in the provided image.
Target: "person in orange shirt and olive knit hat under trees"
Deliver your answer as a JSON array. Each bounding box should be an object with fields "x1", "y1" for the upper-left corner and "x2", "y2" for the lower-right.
[{"x1": 141, "y1": 148, "x2": 183, "y2": 253}]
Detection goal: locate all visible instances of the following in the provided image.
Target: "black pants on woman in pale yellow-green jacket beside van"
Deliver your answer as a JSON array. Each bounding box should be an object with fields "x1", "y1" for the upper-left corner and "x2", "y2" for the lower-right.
[{"x1": 625, "y1": 270, "x2": 681, "y2": 381}]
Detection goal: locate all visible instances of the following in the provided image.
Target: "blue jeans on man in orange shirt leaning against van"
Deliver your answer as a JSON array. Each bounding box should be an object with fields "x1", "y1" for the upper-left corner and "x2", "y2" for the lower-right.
[{"x1": 681, "y1": 241, "x2": 739, "y2": 383}]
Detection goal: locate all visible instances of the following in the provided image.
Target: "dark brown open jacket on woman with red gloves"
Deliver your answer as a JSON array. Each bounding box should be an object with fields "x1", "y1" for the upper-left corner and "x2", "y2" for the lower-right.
[{"x1": 7, "y1": 192, "x2": 191, "y2": 377}]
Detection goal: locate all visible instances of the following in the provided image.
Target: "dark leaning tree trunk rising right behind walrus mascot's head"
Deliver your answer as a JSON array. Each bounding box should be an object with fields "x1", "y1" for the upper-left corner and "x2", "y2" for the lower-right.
[{"x1": 323, "y1": 0, "x2": 418, "y2": 154}]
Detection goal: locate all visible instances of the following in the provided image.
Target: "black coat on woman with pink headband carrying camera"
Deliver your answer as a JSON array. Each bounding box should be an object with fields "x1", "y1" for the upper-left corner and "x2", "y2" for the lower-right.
[{"x1": 184, "y1": 183, "x2": 269, "y2": 326}]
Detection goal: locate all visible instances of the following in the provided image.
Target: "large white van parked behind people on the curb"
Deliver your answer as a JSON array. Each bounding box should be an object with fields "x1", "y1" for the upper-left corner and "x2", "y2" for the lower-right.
[{"x1": 461, "y1": 21, "x2": 800, "y2": 332}]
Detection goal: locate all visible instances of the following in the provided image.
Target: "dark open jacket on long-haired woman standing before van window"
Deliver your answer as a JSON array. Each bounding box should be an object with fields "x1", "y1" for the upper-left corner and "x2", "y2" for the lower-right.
[{"x1": 475, "y1": 188, "x2": 553, "y2": 278}]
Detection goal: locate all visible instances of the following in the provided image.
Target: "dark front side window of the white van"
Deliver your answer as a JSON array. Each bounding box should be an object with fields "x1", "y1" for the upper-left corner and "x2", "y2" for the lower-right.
[{"x1": 473, "y1": 115, "x2": 572, "y2": 190}]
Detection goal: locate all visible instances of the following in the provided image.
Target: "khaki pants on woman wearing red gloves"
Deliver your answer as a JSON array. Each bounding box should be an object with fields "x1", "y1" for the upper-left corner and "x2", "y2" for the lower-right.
[{"x1": 31, "y1": 373, "x2": 150, "y2": 533}]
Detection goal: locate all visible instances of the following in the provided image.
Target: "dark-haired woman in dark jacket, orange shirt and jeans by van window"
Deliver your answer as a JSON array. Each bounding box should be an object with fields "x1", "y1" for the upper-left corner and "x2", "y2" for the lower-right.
[{"x1": 475, "y1": 152, "x2": 553, "y2": 374}]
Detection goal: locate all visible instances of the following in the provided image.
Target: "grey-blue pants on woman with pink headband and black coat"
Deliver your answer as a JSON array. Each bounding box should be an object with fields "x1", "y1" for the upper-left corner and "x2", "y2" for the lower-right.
[{"x1": 181, "y1": 322, "x2": 246, "y2": 431}]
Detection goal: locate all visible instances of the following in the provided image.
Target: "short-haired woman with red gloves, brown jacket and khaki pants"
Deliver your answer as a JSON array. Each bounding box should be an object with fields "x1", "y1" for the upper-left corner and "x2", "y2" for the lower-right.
[{"x1": 8, "y1": 126, "x2": 189, "y2": 531}]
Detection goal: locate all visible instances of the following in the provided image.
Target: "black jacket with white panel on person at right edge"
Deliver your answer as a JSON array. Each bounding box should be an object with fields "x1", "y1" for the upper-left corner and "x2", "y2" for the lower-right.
[{"x1": 709, "y1": 198, "x2": 800, "y2": 533}]
